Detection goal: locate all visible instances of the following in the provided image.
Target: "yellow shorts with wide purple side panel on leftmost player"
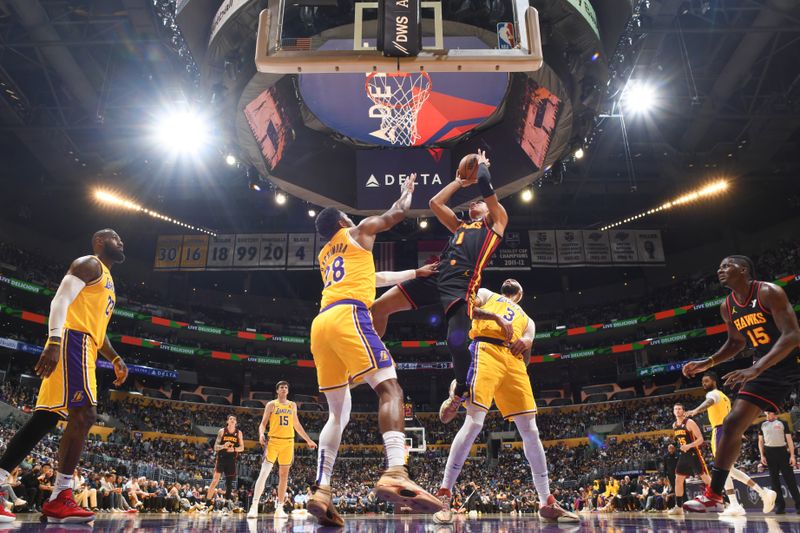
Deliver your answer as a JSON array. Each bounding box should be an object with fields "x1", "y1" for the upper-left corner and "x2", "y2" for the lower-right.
[{"x1": 36, "y1": 329, "x2": 97, "y2": 418}]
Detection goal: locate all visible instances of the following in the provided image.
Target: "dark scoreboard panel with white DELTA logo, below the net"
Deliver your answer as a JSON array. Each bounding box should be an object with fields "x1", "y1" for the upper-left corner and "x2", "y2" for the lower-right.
[{"x1": 356, "y1": 149, "x2": 453, "y2": 210}]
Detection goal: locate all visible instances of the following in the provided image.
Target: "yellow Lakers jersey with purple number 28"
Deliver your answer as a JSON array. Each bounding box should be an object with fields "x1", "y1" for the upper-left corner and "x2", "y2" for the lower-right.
[{"x1": 319, "y1": 228, "x2": 375, "y2": 308}]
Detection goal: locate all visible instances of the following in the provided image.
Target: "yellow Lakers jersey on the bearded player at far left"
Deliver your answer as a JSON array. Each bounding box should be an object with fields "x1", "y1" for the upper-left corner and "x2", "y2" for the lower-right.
[{"x1": 64, "y1": 259, "x2": 117, "y2": 347}]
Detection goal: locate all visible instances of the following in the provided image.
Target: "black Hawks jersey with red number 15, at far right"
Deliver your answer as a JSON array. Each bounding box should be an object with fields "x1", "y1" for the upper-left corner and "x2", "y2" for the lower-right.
[{"x1": 725, "y1": 281, "x2": 800, "y2": 367}]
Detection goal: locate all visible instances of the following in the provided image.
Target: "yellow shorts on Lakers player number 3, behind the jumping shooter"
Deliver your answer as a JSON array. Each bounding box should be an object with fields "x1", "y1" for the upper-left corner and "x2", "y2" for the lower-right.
[{"x1": 467, "y1": 341, "x2": 536, "y2": 418}]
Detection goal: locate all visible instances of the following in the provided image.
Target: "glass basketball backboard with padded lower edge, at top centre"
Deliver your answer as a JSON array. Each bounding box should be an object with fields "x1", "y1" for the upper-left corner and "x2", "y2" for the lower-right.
[{"x1": 255, "y1": 0, "x2": 542, "y2": 74}]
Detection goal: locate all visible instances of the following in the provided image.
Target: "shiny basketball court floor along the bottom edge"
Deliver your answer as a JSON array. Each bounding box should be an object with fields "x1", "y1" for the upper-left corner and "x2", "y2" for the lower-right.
[{"x1": 6, "y1": 513, "x2": 800, "y2": 533}]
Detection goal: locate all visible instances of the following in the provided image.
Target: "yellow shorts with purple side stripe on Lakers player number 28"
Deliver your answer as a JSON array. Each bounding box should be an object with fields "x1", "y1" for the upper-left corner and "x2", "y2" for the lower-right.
[{"x1": 311, "y1": 300, "x2": 394, "y2": 392}]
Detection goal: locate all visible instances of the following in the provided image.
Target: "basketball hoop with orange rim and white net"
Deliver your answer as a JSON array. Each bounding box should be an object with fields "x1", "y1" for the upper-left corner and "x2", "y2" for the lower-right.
[{"x1": 365, "y1": 72, "x2": 432, "y2": 146}]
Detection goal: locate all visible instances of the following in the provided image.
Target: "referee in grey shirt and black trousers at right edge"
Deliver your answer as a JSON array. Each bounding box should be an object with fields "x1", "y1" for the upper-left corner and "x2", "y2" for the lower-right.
[{"x1": 758, "y1": 411, "x2": 800, "y2": 514}]
